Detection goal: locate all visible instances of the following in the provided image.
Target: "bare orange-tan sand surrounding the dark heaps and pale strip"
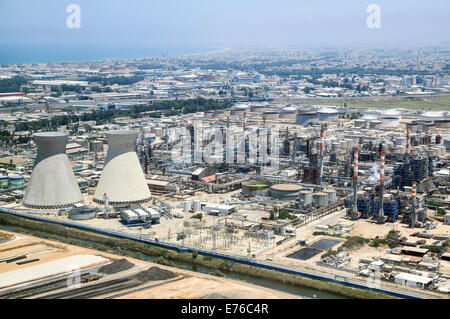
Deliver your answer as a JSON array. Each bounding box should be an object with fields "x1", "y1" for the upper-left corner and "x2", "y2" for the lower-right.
[{"x1": 0, "y1": 231, "x2": 299, "y2": 299}]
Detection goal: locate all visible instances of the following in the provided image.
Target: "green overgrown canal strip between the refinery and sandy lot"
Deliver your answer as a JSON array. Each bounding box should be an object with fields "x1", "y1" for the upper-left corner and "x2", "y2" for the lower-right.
[{"x1": 0, "y1": 214, "x2": 397, "y2": 299}]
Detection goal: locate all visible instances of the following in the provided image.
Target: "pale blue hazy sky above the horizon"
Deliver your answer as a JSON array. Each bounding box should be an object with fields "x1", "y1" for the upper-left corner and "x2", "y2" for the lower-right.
[{"x1": 0, "y1": 0, "x2": 450, "y2": 47}]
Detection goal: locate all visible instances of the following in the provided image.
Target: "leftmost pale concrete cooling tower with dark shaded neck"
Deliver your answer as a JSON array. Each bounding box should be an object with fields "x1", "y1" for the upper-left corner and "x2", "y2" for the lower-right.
[{"x1": 23, "y1": 132, "x2": 83, "y2": 209}]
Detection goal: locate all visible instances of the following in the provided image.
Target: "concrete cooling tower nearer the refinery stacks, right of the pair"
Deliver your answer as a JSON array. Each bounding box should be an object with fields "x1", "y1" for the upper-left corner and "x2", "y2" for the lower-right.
[{"x1": 94, "y1": 130, "x2": 151, "y2": 204}]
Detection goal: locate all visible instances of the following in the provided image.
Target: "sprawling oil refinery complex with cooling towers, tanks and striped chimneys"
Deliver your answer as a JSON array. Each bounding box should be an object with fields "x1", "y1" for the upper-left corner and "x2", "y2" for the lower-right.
[{"x1": 0, "y1": 103, "x2": 450, "y2": 298}]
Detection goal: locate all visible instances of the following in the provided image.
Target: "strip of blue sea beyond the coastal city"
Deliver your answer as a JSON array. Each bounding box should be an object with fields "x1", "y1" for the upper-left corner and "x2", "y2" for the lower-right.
[{"x1": 0, "y1": 43, "x2": 219, "y2": 64}]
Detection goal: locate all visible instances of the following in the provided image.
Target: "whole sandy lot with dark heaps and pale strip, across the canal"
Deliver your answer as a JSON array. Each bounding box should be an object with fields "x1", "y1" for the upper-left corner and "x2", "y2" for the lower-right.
[{"x1": 0, "y1": 230, "x2": 300, "y2": 299}]
